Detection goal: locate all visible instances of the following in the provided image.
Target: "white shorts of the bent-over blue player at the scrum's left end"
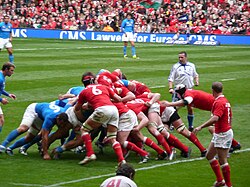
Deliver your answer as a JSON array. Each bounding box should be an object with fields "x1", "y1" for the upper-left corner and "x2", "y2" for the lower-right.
[{"x1": 20, "y1": 103, "x2": 38, "y2": 128}]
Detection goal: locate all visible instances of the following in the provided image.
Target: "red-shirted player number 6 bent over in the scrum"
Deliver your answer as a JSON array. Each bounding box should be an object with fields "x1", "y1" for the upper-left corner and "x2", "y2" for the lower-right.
[{"x1": 75, "y1": 72, "x2": 126, "y2": 165}]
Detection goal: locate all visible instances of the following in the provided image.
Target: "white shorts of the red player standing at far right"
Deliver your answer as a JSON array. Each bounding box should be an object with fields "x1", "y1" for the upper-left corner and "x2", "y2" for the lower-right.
[{"x1": 211, "y1": 129, "x2": 233, "y2": 149}]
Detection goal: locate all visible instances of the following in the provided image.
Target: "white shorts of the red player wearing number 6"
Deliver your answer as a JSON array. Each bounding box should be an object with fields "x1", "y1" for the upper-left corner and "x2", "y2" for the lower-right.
[{"x1": 90, "y1": 106, "x2": 119, "y2": 128}]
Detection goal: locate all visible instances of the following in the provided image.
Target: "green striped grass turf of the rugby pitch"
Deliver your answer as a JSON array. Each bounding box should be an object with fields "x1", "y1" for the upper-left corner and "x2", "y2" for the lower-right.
[{"x1": 0, "y1": 39, "x2": 250, "y2": 187}]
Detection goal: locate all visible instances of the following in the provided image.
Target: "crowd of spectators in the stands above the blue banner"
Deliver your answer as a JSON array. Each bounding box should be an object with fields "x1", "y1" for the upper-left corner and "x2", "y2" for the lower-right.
[{"x1": 0, "y1": 0, "x2": 250, "y2": 35}]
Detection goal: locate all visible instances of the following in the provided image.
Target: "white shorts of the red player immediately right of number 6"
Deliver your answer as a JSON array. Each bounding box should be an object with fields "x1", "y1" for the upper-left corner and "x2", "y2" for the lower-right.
[{"x1": 118, "y1": 110, "x2": 138, "y2": 132}]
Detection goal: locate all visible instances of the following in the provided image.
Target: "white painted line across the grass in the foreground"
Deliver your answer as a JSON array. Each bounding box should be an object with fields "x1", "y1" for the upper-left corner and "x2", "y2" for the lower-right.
[{"x1": 10, "y1": 148, "x2": 250, "y2": 187}]
